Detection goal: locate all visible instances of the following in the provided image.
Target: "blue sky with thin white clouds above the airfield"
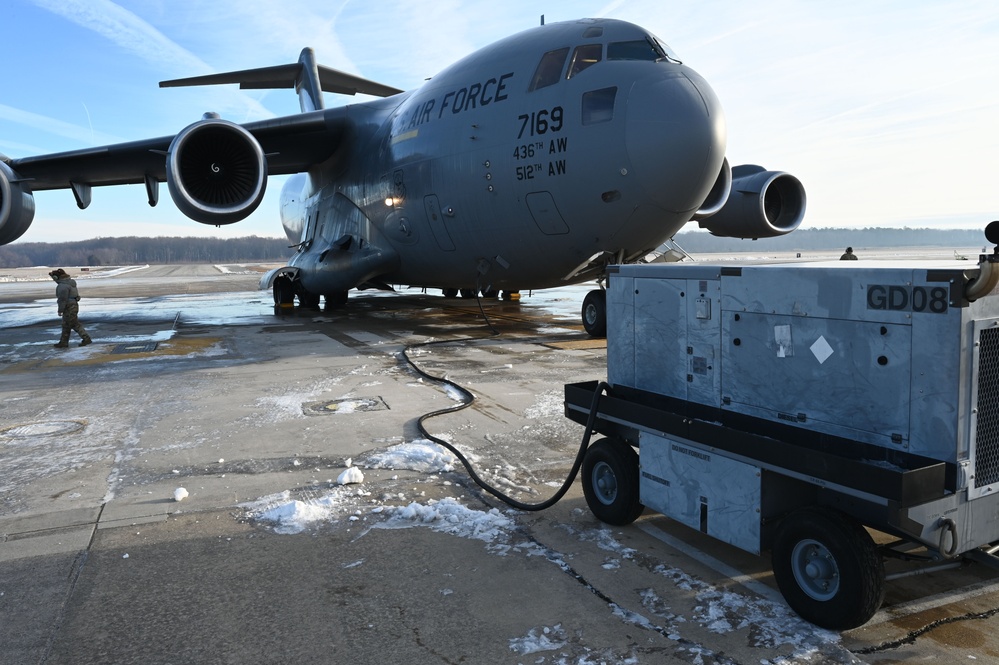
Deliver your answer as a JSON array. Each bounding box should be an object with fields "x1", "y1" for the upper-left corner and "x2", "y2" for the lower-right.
[{"x1": 0, "y1": 0, "x2": 999, "y2": 242}]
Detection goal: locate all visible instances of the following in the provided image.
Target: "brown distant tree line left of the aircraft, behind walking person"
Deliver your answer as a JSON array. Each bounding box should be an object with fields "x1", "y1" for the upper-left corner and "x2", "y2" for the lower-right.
[{"x1": 0, "y1": 236, "x2": 294, "y2": 268}]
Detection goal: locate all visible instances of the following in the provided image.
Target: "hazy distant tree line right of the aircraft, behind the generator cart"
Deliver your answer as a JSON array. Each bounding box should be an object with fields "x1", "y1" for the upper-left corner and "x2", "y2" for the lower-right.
[{"x1": 675, "y1": 228, "x2": 988, "y2": 254}]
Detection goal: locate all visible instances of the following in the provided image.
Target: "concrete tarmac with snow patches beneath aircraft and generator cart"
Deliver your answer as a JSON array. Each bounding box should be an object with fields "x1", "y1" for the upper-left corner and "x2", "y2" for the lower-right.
[{"x1": 0, "y1": 266, "x2": 999, "y2": 665}]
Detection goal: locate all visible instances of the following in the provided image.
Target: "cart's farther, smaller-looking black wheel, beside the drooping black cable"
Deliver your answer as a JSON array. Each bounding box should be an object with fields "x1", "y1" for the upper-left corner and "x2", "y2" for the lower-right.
[{"x1": 582, "y1": 439, "x2": 645, "y2": 526}]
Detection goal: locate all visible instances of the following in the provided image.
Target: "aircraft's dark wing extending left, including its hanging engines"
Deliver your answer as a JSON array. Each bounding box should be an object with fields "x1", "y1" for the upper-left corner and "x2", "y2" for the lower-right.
[{"x1": 0, "y1": 107, "x2": 348, "y2": 245}]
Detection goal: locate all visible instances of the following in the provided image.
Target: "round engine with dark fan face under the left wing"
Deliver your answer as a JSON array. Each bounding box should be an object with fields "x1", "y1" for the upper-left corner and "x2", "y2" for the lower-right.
[{"x1": 166, "y1": 118, "x2": 267, "y2": 225}]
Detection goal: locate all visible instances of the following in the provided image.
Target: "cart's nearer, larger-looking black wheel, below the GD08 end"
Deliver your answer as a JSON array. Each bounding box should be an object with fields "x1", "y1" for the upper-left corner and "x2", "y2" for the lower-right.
[{"x1": 772, "y1": 508, "x2": 885, "y2": 630}]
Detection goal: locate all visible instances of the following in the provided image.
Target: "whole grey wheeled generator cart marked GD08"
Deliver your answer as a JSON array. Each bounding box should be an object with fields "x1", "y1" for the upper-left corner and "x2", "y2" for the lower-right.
[{"x1": 565, "y1": 243, "x2": 999, "y2": 629}]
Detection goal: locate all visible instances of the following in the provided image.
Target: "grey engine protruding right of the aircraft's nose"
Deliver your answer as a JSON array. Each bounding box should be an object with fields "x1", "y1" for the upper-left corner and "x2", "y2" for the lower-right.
[{"x1": 695, "y1": 164, "x2": 805, "y2": 239}]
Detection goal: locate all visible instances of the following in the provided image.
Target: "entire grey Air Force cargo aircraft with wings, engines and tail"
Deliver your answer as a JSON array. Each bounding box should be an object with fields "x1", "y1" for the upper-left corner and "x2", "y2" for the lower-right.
[{"x1": 0, "y1": 19, "x2": 805, "y2": 336}]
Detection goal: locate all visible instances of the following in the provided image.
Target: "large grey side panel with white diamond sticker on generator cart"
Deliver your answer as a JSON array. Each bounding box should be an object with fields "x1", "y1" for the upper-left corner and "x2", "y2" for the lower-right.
[{"x1": 722, "y1": 312, "x2": 911, "y2": 448}]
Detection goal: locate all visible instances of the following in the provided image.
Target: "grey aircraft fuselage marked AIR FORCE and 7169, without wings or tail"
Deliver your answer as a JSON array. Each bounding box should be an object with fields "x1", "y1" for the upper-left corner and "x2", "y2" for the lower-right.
[{"x1": 282, "y1": 20, "x2": 725, "y2": 294}]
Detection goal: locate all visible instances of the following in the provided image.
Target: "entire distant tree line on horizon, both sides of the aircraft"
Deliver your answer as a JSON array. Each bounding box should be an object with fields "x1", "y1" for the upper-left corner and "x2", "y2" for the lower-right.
[{"x1": 0, "y1": 228, "x2": 986, "y2": 268}]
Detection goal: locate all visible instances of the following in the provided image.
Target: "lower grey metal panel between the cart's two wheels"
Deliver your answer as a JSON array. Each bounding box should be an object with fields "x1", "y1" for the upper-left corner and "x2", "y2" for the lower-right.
[{"x1": 639, "y1": 432, "x2": 761, "y2": 554}]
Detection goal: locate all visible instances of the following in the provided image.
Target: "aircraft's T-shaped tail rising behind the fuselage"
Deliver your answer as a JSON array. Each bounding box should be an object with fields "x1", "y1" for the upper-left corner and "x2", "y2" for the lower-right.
[{"x1": 160, "y1": 48, "x2": 402, "y2": 113}]
